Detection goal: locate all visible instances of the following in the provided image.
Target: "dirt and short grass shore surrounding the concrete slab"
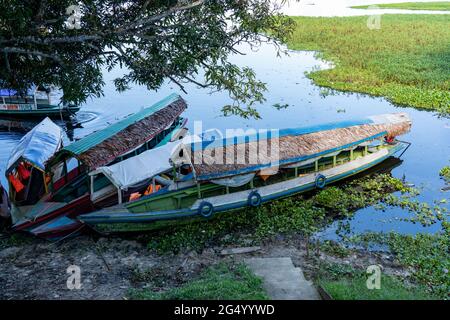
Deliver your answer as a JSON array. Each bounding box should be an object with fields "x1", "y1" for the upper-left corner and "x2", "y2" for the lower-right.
[{"x1": 0, "y1": 230, "x2": 437, "y2": 300}]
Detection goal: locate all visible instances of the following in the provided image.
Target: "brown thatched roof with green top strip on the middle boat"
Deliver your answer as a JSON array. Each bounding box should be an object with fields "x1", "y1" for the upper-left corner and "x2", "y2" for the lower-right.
[{"x1": 53, "y1": 95, "x2": 187, "y2": 170}]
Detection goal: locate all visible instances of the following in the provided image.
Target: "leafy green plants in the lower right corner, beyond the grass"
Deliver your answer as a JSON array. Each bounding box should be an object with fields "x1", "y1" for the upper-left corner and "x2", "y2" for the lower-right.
[{"x1": 353, "y1": 231, "x2": 450, "y2": 299}]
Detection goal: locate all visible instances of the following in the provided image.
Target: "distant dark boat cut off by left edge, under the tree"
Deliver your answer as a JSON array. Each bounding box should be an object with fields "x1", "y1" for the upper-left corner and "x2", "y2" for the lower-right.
[{"x1": 0, "y1": 86, "x2": 80, "y2": 119}]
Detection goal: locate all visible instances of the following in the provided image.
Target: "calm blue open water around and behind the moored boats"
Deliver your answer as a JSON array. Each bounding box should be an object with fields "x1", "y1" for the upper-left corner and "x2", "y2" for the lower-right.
[{"x1": 0, "y1": 45, "x2": 450, "y2": 238}]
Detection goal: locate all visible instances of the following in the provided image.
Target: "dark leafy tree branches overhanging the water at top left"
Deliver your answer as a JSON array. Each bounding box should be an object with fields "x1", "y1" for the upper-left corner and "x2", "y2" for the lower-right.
[{"x1": 0, "y1": 0, "x2": 292, "y2": 116}]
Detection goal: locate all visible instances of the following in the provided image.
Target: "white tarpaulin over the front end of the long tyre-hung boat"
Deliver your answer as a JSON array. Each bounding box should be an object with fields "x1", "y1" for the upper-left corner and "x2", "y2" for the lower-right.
[{"x1": 90, "y1": 140, "x2": 183, "y2": 189}]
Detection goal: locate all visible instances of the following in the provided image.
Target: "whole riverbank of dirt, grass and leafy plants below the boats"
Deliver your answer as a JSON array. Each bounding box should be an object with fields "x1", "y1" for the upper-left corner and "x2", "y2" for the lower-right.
[{"x1": 0, "y1": 174, "x2": 450, "y2": 299}]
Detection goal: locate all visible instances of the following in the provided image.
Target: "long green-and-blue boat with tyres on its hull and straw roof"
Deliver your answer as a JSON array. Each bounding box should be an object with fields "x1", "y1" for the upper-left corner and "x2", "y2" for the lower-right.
[{"x1": 78, "y1": 113, "x2": 411, "y2": 233}]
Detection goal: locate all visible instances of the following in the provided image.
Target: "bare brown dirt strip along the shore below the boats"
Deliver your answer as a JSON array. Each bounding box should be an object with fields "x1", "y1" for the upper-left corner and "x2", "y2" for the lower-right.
[{"x1": 0, "y1": 232, "x2": 405, "y2": 300}]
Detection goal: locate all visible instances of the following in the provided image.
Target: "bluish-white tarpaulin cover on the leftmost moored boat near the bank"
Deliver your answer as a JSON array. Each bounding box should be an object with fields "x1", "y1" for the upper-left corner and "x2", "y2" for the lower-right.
[{"x1": 6, "y1": 118, "x2": 62, "y2": 173}]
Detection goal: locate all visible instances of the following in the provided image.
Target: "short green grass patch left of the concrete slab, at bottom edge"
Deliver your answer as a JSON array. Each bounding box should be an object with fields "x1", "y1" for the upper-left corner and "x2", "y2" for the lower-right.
[{"x1": 130, "y1": 263, "x2": 268, "y2": 300}]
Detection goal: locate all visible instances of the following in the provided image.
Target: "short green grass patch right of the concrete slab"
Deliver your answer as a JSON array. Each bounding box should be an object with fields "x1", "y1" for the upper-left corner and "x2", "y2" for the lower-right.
[{"x1": 318, "y1": 264, "x2": 433, "y2": 300}]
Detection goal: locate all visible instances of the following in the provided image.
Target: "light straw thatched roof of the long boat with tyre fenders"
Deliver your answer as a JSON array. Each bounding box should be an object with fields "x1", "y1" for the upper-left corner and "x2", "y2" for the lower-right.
[{"x1": 190, "y1": 114, "x2": 411, "y2": 180}]
